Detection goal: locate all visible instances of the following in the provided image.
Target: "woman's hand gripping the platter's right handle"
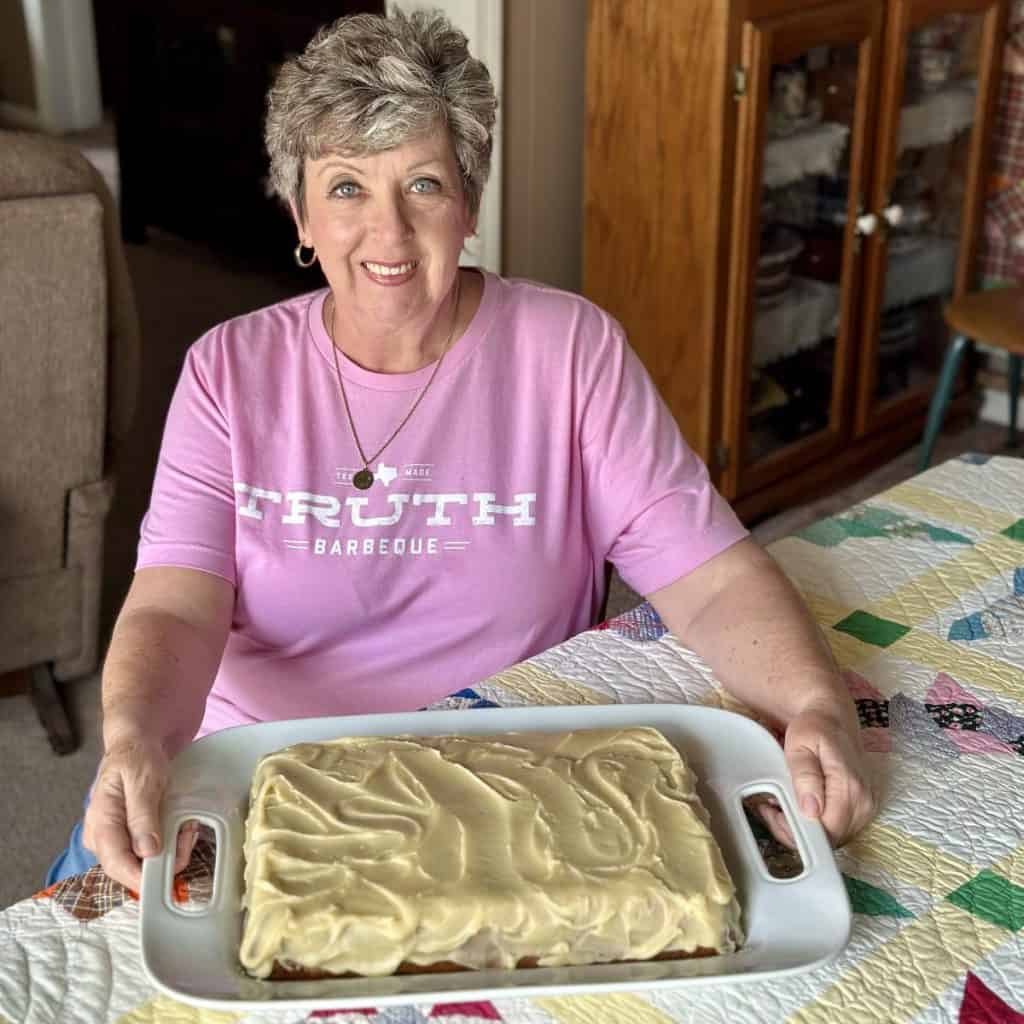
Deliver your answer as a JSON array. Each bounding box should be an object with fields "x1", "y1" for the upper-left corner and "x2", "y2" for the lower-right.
[{"x1": 783, "y1": 709, "x2": 877, "y2": 846}]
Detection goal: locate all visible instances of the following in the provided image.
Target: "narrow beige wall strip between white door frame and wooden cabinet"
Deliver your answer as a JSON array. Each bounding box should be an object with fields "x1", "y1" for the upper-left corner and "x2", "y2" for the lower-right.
[{"x1": 502, "y1": 0, "x2": 587, "y2": 292}]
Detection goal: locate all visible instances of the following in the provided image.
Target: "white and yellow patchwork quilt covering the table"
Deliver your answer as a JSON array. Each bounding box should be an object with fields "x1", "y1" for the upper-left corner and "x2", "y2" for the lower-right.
[{"x1": 0, "y1": 456, "x2": 1024, "y2": 1024}]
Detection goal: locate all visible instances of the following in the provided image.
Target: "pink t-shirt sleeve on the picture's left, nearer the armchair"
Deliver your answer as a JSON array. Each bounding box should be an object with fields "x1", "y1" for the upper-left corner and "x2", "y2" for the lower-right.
[{"x1": 135, "y1": 335, "x2": 236, "y2": 584}]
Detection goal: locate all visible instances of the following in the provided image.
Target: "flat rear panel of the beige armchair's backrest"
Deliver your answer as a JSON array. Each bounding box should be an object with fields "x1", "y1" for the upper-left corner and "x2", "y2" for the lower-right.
[{"x1": 0, "y1": 194, "x2": 108, "y2": 579}]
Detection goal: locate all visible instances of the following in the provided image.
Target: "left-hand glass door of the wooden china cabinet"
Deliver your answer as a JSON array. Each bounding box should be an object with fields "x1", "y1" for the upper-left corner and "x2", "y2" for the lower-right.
[{"x1": 723, "y1": 3, "x2": 882, "y2": 496}]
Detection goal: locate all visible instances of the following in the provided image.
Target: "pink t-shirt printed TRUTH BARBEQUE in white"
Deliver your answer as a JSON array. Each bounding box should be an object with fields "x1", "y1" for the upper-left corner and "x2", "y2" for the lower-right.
[{"x1": 138, "y1": 273, "x2": 746, "y2": 734}]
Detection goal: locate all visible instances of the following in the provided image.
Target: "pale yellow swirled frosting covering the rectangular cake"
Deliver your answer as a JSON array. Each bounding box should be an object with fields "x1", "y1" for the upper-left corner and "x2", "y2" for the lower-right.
[{"x1": 241, "y1": 728, "x2": 740, "y2": 977}]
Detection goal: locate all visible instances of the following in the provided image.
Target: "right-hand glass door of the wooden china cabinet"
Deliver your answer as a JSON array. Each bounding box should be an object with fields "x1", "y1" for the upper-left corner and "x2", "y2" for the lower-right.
[{"x1": 857, "y1": 0, "x2": 998, "y2": 433}]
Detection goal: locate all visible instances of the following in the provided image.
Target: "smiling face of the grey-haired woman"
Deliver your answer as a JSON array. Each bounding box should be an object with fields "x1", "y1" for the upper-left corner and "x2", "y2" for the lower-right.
[{"x1": 292, "y1": 129, "x2": 476, "y2": 326}]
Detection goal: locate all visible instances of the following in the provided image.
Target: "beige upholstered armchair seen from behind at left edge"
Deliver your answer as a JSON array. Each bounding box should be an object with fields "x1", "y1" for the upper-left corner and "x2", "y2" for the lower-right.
[{"x1": 0, "y1": 131, "x2": 138, "y2": 754}]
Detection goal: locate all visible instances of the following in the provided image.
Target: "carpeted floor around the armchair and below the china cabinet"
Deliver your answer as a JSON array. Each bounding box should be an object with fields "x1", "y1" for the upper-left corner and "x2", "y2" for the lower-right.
[{"x1": 0, "y1": 222, "x2": 1019, "y2": 906}]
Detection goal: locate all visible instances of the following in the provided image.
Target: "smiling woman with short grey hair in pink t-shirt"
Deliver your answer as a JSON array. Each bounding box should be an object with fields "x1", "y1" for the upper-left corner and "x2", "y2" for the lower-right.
[{"x1": 65, "y1": 12, "x2": 873, "y2": 888}]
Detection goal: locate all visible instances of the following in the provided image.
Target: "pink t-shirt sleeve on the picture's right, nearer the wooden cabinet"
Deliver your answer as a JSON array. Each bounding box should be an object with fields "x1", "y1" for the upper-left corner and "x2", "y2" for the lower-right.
[{"x1": 580, "y1": 317, "x2": 748, "y2": 595}]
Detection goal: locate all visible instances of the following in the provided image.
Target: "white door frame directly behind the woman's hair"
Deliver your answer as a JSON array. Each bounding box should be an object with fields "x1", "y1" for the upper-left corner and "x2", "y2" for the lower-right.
[{"x1": 387, "y1": 0, "x2": 505, "y2": 273}]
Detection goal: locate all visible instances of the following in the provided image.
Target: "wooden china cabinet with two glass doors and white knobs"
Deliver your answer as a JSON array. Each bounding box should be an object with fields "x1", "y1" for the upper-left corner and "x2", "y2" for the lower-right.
[{"x1": 583, "y1": 0, "x2": 1008, "y2": 519}]
